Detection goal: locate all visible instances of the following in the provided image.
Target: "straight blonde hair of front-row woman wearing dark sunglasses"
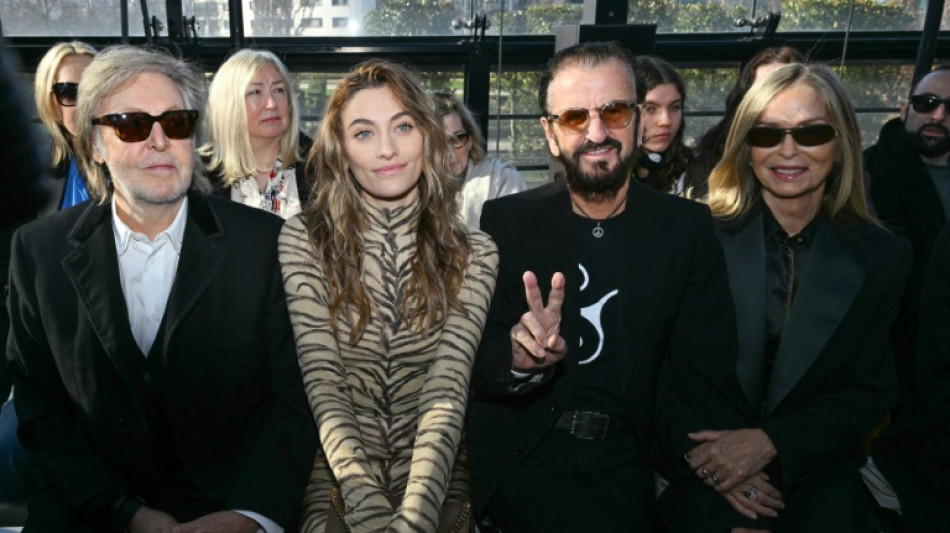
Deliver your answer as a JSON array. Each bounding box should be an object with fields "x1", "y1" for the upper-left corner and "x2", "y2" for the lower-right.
[{"x1": 708, "y1": 63, "x2": 874, "y2": 222}]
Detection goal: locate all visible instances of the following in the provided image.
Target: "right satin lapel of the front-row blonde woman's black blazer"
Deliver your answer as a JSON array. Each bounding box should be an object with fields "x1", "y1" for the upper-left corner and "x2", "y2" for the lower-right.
[{"x1": 765, "y1": 215, "x2": 870, "y2": 413}]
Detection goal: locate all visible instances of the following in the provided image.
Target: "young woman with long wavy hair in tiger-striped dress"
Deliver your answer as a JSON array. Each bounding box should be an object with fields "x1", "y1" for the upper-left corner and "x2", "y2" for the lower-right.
[{"x1": 279, "y1": 60, "x2": 498, "y2": 532}]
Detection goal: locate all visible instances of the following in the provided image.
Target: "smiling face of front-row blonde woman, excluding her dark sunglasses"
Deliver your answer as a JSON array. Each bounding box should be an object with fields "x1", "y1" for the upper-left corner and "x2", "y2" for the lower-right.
[{"x1": 750, "y1": 82, "x2": 838, "y2": 209}]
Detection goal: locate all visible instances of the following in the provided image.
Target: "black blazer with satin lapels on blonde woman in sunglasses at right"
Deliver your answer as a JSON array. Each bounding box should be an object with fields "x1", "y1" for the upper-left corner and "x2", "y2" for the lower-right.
[{"x1": 710, "y1": 210, "x2": 911, "y2": 490}]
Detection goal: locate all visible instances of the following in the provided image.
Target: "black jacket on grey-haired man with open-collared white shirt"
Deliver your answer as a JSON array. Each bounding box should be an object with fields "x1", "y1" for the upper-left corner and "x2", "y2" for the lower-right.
[{"x1": 7, "y1": 193, "x2": 317, "y2": 531}]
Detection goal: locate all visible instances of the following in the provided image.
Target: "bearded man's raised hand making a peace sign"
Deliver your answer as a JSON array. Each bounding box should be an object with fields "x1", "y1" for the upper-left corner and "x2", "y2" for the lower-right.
[{"x1": 511, "y1": 271, "x2": 567, "y2": 372}]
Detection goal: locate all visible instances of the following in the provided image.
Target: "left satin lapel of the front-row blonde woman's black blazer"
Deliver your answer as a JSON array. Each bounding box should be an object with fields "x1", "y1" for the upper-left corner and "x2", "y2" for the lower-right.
[{"x1": 717, "y1": 212, "x2": 765, "y2": 413}]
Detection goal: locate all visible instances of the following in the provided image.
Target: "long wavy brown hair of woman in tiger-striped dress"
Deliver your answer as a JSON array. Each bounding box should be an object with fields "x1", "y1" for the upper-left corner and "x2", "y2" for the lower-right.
[{"x1": 303, "y1": 59, "x2": 470, "y2": 343}]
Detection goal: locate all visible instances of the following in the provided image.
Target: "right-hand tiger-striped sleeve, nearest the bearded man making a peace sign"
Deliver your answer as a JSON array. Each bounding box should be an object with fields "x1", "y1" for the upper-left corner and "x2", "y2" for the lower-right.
[{"x1": 389, "y1": 232, "x2": 498, "y2": 532}]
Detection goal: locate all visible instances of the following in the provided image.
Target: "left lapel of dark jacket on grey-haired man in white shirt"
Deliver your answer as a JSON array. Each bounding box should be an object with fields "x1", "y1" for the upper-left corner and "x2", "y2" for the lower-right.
[{"x1": 62, "y1": 201, "x2": 138, "y2": 389}]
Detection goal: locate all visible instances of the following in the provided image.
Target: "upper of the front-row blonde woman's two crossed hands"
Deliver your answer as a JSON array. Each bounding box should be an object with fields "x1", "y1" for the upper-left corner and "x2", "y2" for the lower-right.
[{"x1": 686, "y1": 429, "x2": 776, "y2": 492}]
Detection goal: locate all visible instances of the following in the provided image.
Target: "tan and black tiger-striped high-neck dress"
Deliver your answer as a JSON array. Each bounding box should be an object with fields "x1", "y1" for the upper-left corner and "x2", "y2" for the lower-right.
[{"x1": 279, "y1": 200, "x2": 498, "y2": 533}]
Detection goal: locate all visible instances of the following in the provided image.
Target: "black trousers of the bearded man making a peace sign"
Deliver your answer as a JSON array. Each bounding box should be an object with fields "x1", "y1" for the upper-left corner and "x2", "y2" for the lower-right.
[{"x1": 488, "y1": 429, "x2": 655, "y2": 533}]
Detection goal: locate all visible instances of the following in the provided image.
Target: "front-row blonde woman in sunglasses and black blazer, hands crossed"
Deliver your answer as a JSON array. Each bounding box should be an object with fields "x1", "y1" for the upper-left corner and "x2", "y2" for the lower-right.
[{"x1": 662, "y1": 64, "x2": 910, "y2": 533}]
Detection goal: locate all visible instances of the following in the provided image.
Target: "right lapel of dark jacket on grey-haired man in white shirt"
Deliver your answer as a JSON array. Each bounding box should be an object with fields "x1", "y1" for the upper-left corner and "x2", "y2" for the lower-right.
[{"x1": 162, "y1": 194, "x2": 228, "y2": 357}]
